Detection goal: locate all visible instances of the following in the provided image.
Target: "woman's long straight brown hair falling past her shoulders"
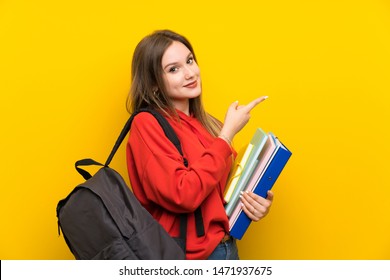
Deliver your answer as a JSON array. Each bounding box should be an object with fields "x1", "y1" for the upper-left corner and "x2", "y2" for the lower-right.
[{"x1": 126, "y1": 30, "x2": 222, "y2": 136}]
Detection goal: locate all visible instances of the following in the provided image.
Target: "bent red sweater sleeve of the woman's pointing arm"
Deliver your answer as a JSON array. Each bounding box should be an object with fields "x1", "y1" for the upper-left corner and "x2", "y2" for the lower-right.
[{"x1": 129, "y1": 113, "x2": 232, "y2": 213}]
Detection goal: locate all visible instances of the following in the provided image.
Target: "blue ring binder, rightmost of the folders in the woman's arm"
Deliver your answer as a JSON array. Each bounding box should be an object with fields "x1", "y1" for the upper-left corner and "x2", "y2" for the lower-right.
[{"x1": 230, "y1": 133, "x2": 292, "y2": 239}]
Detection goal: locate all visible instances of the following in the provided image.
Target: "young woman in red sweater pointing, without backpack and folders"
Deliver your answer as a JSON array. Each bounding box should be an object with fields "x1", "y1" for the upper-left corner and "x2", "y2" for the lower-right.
[{"x1": 126, "y1": 30, "x2": 273, "y2": 259}]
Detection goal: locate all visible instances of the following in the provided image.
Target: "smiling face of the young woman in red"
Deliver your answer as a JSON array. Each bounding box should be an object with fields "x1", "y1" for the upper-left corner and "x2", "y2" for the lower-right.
[{"x1": 161, "y1": 41, "x2": 202, "y2": 114}]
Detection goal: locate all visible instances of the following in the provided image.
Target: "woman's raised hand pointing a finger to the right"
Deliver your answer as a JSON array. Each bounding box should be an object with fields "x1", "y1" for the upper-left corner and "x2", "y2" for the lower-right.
[{"x1": 220, "y1": 96, "x2": 268, "y2": 141}]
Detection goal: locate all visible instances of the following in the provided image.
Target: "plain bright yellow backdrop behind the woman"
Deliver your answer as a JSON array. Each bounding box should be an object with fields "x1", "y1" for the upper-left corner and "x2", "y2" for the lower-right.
[{"x1": 0, "y1": 0, "x2": 390, "y2": 259}]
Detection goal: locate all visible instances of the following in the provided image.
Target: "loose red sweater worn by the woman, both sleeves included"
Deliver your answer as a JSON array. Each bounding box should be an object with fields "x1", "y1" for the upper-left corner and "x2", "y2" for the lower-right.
[{"x1": 126, "y1": 111, "x2": 236, "y2": 259}]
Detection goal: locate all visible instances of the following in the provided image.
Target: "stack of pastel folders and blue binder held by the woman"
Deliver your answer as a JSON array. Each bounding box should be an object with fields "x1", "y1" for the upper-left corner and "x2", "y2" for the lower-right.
[{"x1": 224, "y1": 128, "x2": 291, "y2": 239}]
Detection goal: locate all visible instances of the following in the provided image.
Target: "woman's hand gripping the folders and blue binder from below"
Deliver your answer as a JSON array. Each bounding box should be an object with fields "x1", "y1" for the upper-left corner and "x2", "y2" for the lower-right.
[{"x1": 241, "y1": 191, "x2": 274, "y2": 222}]
